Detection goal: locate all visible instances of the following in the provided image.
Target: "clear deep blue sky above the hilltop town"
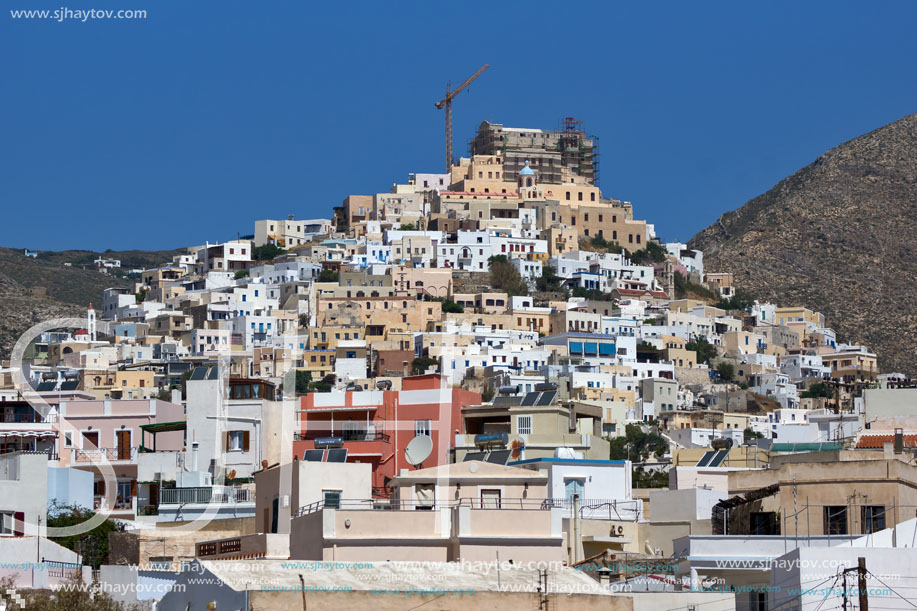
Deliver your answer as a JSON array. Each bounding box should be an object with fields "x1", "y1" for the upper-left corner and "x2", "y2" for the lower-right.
[{"x1": 0, "y1": 0, "x2": 917, "y2": 250}]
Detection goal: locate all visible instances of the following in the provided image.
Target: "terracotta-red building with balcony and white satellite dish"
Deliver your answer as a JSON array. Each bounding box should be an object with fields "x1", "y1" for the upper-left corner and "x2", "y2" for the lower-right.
[{"x1": 293, "y1": 374, "x2": 481, "y2": 496}]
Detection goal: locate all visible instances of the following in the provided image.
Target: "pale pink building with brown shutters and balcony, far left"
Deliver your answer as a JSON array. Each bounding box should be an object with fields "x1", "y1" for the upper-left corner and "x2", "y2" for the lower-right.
[{"x1": 59, "y1": 399, "x2": 185, "y2": 519}]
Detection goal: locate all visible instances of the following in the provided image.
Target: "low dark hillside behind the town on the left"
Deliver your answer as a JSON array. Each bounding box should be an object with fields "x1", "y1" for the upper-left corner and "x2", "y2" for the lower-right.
[{"x1": 0, "y1": 248, "x2": 178, "y2": 360}]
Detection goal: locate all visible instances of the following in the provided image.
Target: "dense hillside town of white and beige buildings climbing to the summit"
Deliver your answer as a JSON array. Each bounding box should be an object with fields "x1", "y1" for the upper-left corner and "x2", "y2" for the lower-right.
[{"x1": 0, "y1": 119, "x2": 917, "y2": 611}]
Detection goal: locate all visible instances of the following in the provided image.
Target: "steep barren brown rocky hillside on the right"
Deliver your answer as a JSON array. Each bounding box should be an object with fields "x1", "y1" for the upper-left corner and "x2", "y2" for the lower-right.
[{"x1": 691, "y1": 114, "x2": 917, "y2": 376}]
